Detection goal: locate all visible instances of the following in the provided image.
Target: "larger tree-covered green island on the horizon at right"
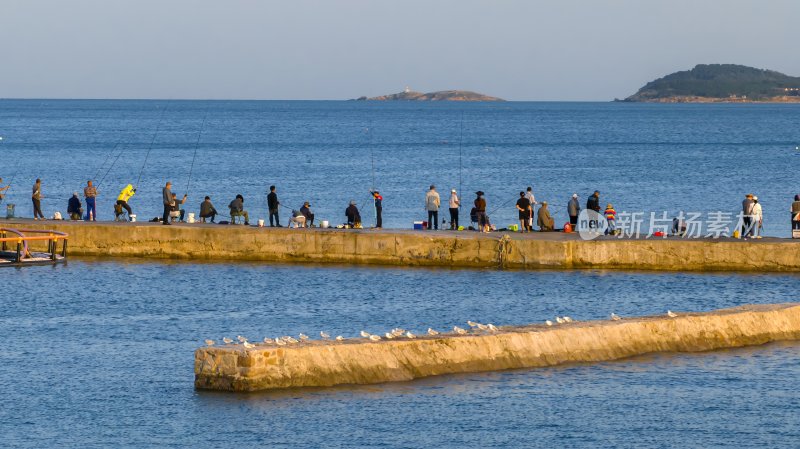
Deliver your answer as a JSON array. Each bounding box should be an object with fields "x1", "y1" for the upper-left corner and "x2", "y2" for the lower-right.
[{"x1": 616, "y1": 64, "x2": 800, "y2": 103}]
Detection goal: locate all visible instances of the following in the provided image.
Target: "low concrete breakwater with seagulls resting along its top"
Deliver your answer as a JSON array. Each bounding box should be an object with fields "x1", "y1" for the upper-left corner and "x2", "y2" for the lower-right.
[{"x1": 194, "y1": 303, "x2": 800, "y2": 391}]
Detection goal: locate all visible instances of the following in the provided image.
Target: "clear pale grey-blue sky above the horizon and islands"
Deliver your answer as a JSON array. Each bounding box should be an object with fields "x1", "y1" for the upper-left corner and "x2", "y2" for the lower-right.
[{"x1": 0, "y1": 0, "x2": 800, "y2": 101}]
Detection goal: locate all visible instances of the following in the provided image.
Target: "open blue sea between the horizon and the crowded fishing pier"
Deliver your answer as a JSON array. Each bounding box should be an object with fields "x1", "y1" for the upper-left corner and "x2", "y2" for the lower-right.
[{"x1": 0, "y1": 100, "x2": 800, "y2": 237}]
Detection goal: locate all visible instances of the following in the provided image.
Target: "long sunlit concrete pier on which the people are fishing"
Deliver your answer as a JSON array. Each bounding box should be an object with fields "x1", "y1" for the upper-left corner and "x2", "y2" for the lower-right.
[{"x1": 0, "y1": 220, "x2": 800, "y2": 271}]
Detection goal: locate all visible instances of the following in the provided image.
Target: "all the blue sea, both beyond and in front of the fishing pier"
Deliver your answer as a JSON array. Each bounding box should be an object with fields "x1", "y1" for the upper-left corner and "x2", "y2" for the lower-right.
[{"x1": 0, "y1": 100, "x2": 800, "y2": 448}]
